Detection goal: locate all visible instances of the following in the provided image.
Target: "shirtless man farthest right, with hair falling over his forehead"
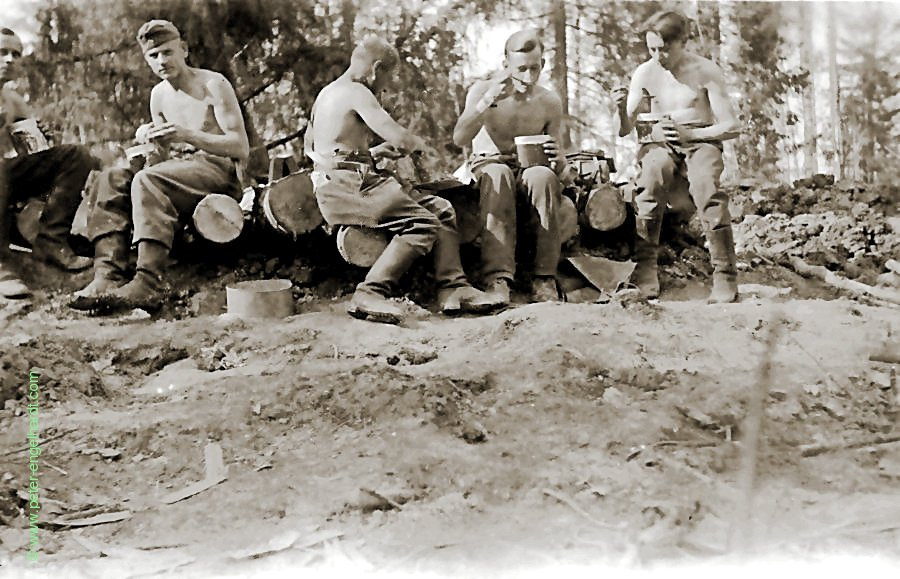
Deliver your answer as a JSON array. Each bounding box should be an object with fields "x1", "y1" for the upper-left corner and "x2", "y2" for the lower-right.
[{"x1": 616, "y1": 12, "x2": 739, "y2": 303}]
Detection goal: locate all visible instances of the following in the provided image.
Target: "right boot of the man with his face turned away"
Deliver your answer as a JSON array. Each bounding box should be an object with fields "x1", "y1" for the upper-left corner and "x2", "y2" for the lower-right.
[{"x1": 432, "y1": 225, "x2": 508, "y2": 314}]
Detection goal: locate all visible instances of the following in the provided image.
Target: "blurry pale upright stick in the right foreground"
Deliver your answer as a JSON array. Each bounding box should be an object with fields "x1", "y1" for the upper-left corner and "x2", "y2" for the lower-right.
[{"x1": 728, "y1": 310, "x2": 783, "y2": 551}]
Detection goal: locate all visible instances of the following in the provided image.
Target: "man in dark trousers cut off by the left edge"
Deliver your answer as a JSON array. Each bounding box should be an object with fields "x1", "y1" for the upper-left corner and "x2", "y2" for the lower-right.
[{"x1": 0, "y1": 28, "x2": 97, "y2": 298}]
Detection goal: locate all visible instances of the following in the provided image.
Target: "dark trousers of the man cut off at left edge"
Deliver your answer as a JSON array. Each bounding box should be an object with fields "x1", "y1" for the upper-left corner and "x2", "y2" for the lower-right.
[{"x1": 2, "y1": 145, "x2": 98, "y2": 241}]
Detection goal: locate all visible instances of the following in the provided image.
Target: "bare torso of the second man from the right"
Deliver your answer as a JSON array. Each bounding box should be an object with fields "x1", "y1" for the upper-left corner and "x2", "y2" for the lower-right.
[{"x1": 472, "y1": 81, "x2": 562, "y2": 154}]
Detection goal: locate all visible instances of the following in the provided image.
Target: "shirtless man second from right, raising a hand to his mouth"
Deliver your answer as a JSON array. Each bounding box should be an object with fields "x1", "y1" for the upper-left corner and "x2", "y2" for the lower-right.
[{"x1": 453, "y1": 30, "x2": 566, "y2": 302}]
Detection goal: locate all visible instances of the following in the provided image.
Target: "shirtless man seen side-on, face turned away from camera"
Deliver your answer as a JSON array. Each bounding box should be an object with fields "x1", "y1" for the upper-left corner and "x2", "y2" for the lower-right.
[{"x1": 304, "y1": 38, "x2": 501, "y2": 324}]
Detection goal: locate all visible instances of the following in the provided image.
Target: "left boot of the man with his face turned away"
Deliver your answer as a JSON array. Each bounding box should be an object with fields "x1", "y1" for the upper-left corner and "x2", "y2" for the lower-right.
[{"x1": 347, "y1": 236, "x2": 421, "y2": 324}]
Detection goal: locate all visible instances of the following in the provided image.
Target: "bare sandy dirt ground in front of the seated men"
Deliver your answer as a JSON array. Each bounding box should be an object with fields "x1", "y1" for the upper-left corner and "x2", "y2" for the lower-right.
[{"x1": 0, "y1": 241, "x2": 900, "y2": 577}]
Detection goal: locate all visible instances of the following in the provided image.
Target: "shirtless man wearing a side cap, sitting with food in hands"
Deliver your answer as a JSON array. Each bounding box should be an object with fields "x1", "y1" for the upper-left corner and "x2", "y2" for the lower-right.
[{"x1": 72, "y1": 20, "x2": 249, "y2": 311}]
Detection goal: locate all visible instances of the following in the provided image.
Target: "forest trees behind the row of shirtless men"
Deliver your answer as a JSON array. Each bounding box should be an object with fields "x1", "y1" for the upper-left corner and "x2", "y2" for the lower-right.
[{"x1": 0, "y1": 0, "x2": 900, "y2": 184}]
